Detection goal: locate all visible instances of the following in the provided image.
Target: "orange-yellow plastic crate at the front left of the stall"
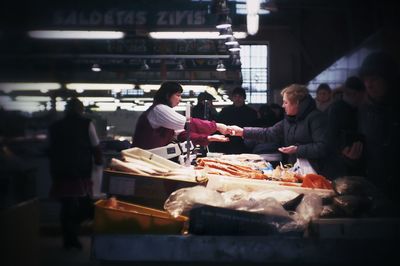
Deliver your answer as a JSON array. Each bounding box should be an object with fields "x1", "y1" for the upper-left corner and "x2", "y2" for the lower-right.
[{"x1": 94, "y1": 200, "x2": 188, "y2": 234}]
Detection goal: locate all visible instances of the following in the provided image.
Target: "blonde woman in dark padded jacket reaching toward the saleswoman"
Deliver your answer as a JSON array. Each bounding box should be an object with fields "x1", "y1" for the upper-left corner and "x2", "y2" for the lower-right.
[{"x1": 229, "y1": 84, "x2": 329, "y2": 174}]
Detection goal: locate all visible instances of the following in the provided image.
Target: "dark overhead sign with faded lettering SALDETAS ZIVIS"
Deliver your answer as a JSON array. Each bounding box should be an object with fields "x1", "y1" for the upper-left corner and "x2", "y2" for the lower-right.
[{"x1": 29, "y1": 1, "x2": 242, "y2": 28}]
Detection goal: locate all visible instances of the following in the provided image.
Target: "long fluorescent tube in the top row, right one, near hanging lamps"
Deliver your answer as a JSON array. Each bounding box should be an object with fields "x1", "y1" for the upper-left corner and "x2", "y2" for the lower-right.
[{"x1": 149, "y1": 31, "x2": 247, "y2": 39}]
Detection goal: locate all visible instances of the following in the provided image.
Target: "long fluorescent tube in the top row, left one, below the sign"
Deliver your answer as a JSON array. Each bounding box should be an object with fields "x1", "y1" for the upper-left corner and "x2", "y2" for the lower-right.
[{"x1": 28, "y1": 30, "x2": 125, "y2": 39}]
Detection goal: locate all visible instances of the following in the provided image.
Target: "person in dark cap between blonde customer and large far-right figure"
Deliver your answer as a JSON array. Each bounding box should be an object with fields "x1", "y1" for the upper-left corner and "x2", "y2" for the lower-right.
[{"x1": 327, "y1": 76, "x2": 365, "y2": 178}]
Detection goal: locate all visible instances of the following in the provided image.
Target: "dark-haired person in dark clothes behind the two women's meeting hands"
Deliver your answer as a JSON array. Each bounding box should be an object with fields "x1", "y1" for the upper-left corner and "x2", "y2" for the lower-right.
[{"x1": 214, "y1": 87, "x2": 257, "y2": 154}]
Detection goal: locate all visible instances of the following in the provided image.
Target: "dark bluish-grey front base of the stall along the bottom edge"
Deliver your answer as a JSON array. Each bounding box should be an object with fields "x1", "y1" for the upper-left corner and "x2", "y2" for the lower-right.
[{"x1": 92, "y1": 231, "x2": 398, "y2": 265}]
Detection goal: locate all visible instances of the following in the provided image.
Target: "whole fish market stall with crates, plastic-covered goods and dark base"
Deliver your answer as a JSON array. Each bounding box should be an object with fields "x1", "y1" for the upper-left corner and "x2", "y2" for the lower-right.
[{"x1": 93, "y1": 149, "x2": 400, "y2": 264}]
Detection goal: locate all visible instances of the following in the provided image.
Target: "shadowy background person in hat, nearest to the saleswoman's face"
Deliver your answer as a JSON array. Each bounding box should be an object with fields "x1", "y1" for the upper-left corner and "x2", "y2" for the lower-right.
[{"x1": 192, "y1": 91, "x2": 218, "y2": 121}]
